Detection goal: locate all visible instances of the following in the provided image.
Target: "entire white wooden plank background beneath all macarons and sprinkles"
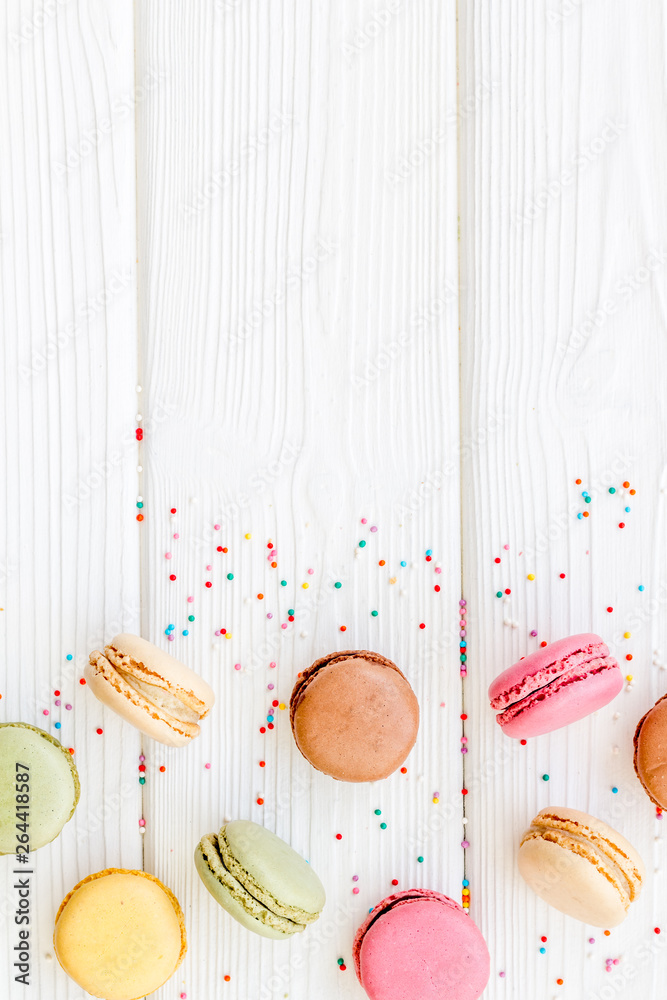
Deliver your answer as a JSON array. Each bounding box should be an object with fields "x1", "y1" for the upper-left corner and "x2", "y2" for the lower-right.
[{"x1": 0, "y1": 0, "x2": 667, "y2": 1000}]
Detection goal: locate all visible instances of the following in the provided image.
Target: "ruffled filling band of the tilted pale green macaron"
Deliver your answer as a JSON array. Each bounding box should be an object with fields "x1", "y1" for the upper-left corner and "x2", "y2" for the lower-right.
[{"x1": 199, "y1": 829, "x2": 310, "y2": 934}]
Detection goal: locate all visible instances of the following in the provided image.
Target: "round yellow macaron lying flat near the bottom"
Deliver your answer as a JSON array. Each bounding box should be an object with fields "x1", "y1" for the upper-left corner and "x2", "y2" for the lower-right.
[{"x1": 53, "y1": 868, "x2": 187, "y2": 1000}]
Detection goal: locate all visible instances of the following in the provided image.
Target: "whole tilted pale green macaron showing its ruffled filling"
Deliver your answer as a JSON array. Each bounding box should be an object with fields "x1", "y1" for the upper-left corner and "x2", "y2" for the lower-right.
[{"x1": 195, "y1": 820, "x2": 326, "y2": 940}]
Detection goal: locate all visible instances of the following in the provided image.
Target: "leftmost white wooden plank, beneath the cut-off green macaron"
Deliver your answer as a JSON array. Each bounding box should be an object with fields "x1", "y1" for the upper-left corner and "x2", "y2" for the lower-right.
[{"x1": 0, "y1": 0, "x2": 142, "y2": 1000}]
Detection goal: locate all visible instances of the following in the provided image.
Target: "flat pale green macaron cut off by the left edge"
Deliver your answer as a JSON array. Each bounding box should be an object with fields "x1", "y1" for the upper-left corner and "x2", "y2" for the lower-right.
[{"x1": 0, "y1": 722, "x2": 81, "y2": 854}]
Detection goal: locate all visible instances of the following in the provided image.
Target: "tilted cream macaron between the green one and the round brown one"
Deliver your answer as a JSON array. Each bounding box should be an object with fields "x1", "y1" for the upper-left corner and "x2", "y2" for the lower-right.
[{"x1": 84, "y1": 633, "x2": 215, "y2": 747}]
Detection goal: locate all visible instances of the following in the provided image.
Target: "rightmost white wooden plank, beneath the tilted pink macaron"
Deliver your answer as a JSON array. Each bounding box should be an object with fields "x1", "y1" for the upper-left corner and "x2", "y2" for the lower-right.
[{"x1": 461, "y1": 2, "x2": 667, "y2": 1000}]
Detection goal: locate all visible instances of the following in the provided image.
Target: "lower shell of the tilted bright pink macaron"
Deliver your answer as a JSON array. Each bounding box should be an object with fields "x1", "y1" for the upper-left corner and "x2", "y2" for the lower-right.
[{"x1": 496, "y1": 658, "x2": 623, "y2": 739}]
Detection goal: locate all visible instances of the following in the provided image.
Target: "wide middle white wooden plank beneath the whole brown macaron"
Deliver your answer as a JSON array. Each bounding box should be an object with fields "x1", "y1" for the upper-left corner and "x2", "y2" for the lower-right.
[{"x1": 137, "y1": 0, "x2": 462, "y2": 1000}]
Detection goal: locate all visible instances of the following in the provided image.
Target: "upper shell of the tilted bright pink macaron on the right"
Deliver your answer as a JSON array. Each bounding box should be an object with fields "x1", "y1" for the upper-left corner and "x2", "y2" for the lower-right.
[{"x1": 489, "y1": 632, "x2": 609, "y2": 709}]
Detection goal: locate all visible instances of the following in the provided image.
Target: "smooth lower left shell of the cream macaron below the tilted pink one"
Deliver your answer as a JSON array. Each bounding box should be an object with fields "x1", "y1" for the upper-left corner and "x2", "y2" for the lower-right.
[{"x1": 519, "y1": 840, "x2": 627, "y2": 927}]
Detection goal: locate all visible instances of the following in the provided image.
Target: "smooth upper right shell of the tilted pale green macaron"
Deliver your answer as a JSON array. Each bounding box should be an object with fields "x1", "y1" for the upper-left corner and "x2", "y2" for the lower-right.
[{"x1": 219, "y1": 820, "x2": 326, "y2": 923}]
